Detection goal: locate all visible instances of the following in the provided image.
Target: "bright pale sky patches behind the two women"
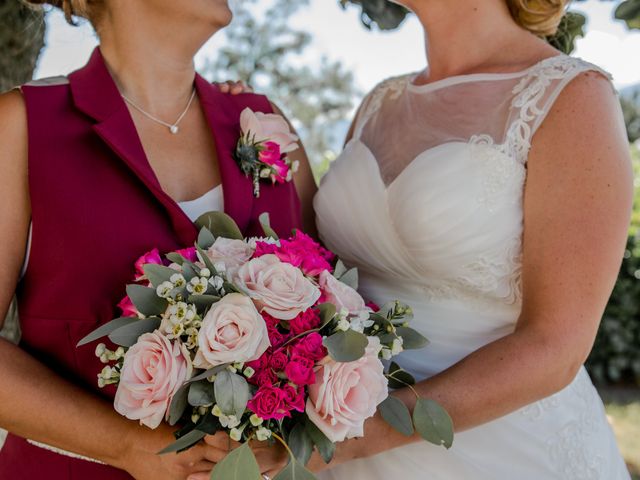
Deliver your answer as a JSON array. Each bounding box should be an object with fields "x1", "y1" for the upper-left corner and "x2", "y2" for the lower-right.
[{"x1": 36, "y1": 0, "x2": 640, "y2": 92}]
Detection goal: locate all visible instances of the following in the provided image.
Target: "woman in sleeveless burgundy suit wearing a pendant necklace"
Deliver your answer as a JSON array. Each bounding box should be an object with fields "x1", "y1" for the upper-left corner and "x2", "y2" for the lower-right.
[{"x1": 0, "y1": 0, "x2": 315, "y2": 480}]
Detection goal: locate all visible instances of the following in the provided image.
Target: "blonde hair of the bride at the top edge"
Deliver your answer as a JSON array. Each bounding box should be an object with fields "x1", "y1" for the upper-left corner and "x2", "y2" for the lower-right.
[{"x1": 507, "y1": 0, "x2": 570, "y2": 37}]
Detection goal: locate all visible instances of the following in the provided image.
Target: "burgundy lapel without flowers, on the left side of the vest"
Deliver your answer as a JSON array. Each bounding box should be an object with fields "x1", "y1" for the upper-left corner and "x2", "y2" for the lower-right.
[{"x1": 69, "y1": 48, "x2": 198, "y2": 246}]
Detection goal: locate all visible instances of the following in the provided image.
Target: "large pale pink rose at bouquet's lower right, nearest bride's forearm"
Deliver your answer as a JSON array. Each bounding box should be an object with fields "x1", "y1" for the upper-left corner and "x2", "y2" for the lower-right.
[{"x1": 305, "y1": 337, "x2": 389, "y2": 442}]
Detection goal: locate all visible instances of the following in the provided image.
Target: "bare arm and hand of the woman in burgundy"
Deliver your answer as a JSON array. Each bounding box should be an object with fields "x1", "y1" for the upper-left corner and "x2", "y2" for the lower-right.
[{"x1": 0, "y1": 91, "x2": 226, "y2": 480}]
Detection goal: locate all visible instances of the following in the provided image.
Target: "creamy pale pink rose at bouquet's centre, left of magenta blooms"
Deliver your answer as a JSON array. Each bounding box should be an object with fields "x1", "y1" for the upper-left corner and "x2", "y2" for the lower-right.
[{"x1": 193, "y1": 293, "x2": 271, "y2": 369}]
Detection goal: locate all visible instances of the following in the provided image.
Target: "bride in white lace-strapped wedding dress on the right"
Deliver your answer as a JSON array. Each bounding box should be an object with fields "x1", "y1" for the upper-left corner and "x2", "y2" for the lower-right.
[{"x1": 239, "y1": 0, "x2": 632, "y2": 480}]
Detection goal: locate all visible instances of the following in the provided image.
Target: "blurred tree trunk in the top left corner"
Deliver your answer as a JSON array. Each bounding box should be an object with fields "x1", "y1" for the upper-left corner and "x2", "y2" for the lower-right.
[{"x1": 0, "y1": 0, "x2": 45, "y2": 92}]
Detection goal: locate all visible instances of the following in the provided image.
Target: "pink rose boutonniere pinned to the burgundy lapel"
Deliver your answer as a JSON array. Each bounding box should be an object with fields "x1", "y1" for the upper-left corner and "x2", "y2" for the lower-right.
[{"x1": 234, "y1": 108, "x2": 299, "y2": 197}]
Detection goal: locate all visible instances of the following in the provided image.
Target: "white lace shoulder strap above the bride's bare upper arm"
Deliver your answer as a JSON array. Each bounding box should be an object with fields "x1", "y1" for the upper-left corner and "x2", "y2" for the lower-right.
[{"x1": 506, "y1": 55, "x2": 615, "y2": 163}]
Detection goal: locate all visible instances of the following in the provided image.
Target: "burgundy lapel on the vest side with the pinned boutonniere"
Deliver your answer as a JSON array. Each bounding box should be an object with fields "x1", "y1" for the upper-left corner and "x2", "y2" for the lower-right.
[{"x1": 195, "y1": 75, "x2": 254, "y2": 231}]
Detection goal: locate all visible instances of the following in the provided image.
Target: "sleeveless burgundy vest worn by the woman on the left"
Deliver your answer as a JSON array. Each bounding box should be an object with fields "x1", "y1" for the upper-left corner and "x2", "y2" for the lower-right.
[{"x1": 0, "y1": 49, "x2": 301, "y2": 480}]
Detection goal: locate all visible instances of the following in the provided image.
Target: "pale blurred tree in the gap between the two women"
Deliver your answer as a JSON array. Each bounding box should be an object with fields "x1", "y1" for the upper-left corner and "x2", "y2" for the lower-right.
[{"x1": 204, "y1": 0, "x2": 358, "y2": 175}]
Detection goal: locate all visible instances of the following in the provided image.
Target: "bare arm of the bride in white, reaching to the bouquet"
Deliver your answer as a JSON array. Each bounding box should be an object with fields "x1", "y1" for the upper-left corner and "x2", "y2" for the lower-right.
[{"x1": 312, "y1": 73, "x2": 633, "y2": 470}]
